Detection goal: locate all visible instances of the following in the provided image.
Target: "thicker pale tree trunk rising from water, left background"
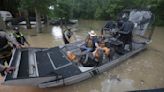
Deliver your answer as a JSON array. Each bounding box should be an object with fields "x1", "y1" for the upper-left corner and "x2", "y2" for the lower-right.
[{"x1": 35, "y1": 8, "x2": 42, "y2": 33}]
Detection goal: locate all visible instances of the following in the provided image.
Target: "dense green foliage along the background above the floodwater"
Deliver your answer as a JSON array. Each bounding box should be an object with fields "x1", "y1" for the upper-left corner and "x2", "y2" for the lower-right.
[{"x1": 17, "y1": 0, "x2": 164, "y2": 24}]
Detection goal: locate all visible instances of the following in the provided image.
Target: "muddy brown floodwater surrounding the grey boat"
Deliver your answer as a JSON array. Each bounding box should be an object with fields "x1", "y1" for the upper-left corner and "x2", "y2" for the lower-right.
[{"x1": 0, "y1": 21, "x2": 164, "y2": 92}]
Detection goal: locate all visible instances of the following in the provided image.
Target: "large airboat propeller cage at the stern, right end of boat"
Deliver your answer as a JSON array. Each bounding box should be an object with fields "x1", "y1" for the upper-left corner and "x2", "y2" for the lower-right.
[{"x1": 103, "y1": 9, "x2": 155, "y2": 36}]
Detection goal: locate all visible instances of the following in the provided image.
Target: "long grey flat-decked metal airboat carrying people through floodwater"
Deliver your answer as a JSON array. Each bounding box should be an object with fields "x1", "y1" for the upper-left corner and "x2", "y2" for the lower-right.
[{"x1": 3, "y1": 9, "x2": 152, "y2": 88}]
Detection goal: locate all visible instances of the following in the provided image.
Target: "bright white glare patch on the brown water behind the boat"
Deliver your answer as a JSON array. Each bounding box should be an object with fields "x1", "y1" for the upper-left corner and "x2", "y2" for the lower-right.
[{"x1": 52, "y1": 26, "x2": 62, "y2": 39}]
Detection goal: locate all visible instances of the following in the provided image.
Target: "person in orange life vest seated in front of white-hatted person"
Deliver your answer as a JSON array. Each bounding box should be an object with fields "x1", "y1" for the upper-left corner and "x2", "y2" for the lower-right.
[{"x1": 79, "y1": 40, "x2": 110, "y2": 67}]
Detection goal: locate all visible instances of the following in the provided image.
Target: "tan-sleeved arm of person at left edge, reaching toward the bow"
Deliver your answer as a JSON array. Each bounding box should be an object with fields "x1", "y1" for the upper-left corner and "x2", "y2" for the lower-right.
[{"x1": 0, "y1": 32, "x2": 20, "y2": 48}]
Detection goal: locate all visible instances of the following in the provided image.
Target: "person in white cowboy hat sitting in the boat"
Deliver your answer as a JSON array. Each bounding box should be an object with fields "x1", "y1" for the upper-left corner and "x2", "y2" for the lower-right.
[{"x1": 80, "y1": 30, "x2": 98, "y2": 52}]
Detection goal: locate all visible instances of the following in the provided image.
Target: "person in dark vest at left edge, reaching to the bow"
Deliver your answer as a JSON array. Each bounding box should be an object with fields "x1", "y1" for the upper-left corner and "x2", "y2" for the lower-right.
[{"x1": 0, "y1": 29, "x2": 21, "y2": 75}]
